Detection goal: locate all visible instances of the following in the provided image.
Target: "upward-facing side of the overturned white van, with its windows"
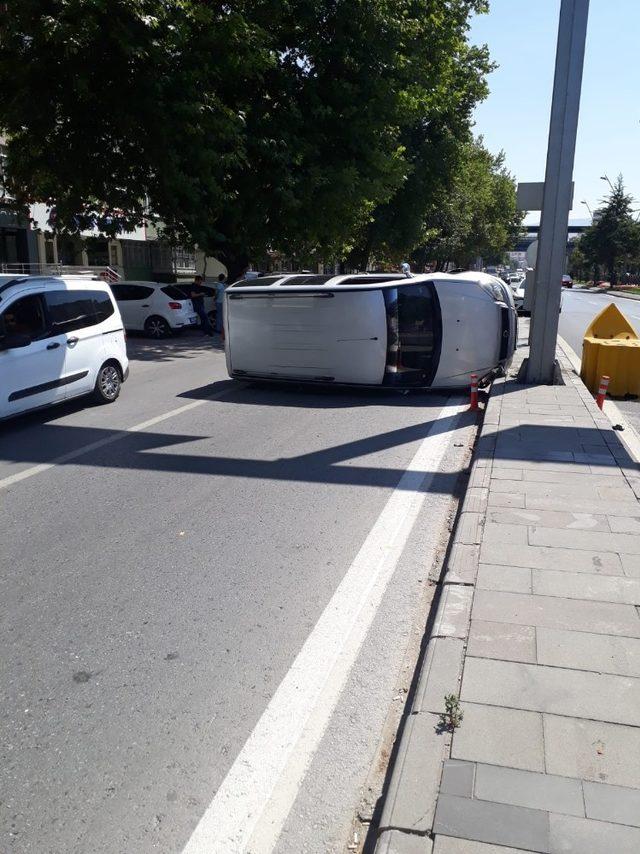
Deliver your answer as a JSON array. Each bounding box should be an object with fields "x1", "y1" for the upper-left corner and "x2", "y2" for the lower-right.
[{"x1": 228, "y1": 270, "x2": 496, "y2": 291}]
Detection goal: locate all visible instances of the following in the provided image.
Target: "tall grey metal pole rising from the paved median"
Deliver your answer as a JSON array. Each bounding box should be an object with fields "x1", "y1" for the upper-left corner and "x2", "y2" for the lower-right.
[{"x1": 526, "y1": 0, "x2": 589, "y2": 383}]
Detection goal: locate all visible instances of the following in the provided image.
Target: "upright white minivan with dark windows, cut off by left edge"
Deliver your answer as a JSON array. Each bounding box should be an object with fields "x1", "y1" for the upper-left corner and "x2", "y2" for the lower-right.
[{"x1": 0, "y1": 276, "x2": 129, "y2": 419}]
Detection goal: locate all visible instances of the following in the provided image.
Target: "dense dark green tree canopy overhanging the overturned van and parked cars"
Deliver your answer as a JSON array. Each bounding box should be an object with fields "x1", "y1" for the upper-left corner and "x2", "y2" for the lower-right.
[{"x1": 0, "y1": 0, "x2": 490, "y2": 274}]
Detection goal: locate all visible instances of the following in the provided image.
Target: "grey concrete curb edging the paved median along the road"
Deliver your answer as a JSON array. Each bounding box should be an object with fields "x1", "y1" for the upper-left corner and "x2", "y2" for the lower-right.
[{"x1": 375, "y1": 377, "x2": 506, "y2": 854}]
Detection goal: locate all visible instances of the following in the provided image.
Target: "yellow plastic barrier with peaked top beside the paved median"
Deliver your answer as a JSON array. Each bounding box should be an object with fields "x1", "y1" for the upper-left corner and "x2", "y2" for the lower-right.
[{"x1": 580, "y1": 303, "x2": 640, "y2": 397}]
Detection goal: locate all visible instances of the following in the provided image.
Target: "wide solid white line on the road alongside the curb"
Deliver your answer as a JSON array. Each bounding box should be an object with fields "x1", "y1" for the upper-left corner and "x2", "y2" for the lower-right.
[{"x1": 183, "y1": 402, "x2": 468, "y2": 854}]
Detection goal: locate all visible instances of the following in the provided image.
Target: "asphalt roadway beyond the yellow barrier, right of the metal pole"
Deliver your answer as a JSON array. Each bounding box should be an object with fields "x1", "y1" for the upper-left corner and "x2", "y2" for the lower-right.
[{"x1": 559, "y1": 289, "x2": 640, "y2": 434}]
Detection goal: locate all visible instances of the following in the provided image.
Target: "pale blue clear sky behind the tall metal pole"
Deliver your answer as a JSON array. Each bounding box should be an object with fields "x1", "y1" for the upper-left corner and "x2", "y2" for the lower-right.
[{"x1": 470, "y1": 0, "x2": 640, "y2": 223}]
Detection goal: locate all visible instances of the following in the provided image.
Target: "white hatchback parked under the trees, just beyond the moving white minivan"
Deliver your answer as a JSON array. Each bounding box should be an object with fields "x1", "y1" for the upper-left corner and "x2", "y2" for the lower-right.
[{"x1": 111, "y1": 282, "x2": 198, "y2": 338}]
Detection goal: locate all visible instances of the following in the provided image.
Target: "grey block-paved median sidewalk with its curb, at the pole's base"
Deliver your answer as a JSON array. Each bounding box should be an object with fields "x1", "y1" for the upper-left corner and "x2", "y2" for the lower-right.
[{"x1": 376, "y1": 336, "x2": 640, "y2": 854}]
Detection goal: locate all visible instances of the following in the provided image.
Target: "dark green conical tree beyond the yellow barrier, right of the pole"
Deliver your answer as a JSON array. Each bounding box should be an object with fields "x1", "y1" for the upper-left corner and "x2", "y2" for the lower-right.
[{"x1": 574, "y1": 175, "x2": 640, "y2": 285}]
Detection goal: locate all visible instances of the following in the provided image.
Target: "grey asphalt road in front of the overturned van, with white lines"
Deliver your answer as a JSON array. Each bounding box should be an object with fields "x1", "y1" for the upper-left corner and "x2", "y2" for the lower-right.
[{"x1": 0, "y1": 336, "x2": 473, "y2": 854}]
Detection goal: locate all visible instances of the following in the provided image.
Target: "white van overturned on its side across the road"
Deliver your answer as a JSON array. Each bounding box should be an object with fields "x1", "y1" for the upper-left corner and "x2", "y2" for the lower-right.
[{"x1": 225, "y1": 273, "x2": 517, "y2": 388}]
